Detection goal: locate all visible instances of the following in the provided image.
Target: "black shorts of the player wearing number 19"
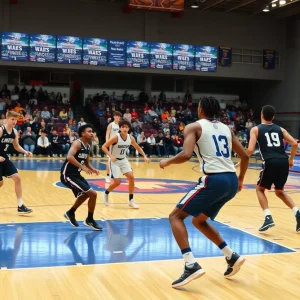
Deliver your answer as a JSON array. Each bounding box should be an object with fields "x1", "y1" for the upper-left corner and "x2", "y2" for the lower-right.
[{"x1": 257, "y1": 158, "x2": 289, "y2": 190}]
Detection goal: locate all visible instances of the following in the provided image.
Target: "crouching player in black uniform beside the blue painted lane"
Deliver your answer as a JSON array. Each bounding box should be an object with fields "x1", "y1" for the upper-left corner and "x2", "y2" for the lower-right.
[{"x1": 60, "y1": 124, "x2": 102, "y2": 230}]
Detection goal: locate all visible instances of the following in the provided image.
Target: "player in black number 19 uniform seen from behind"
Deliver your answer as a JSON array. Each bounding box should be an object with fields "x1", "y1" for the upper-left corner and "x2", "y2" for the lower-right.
[{"x1": 241, "y1": 105, "x2": 300, "y2": 233}]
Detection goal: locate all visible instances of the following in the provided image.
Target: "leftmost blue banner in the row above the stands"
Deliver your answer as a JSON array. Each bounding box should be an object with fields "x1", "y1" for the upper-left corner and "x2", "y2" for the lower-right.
[{"x1": 1, "y1": 32, "x2": 29, "y2": 61}]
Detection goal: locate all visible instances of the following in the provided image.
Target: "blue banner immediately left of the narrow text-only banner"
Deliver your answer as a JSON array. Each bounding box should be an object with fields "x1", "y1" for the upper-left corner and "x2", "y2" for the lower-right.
[{"x1": 83, "y1": 38, "x2": 107, "y2": 66}]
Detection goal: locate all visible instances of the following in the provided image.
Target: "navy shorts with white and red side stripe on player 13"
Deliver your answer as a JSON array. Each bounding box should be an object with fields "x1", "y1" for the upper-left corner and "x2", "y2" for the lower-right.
[{"x1": 176, "y1": 173, "x2": 238, "y2": 220}]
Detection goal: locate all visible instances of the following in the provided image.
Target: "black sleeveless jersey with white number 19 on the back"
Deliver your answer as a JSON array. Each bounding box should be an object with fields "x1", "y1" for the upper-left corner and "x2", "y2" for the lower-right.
[{"x1": 257, "y1": 124, "x2": 288, "y2": 160}]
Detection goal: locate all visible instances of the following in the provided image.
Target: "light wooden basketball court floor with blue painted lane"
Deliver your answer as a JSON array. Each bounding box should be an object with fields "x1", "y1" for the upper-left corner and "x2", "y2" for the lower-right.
[{"x1": 0, "y1": 158, "x2": 300, "y2": 300}]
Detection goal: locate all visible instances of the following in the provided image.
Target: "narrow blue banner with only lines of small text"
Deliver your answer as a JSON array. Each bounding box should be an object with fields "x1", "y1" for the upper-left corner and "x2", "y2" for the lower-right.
[{"x1": 108, "y1": 40, "x2": 126, "y2": 67}]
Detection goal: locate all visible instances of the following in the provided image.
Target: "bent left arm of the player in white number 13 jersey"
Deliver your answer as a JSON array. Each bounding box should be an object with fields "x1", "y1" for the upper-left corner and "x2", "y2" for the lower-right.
[{"x1": 160, "y1": 123, "x2": 202, "y2": 168}]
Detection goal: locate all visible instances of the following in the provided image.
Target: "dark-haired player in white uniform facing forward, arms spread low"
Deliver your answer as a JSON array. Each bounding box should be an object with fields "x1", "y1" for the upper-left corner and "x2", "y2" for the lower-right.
[{"x1": 102, "y1": 120, "x2": 149, "y2": 208}]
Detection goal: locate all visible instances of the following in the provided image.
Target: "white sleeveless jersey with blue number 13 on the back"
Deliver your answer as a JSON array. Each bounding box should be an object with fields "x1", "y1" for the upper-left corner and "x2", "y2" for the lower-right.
[{"x1": 195, "y1": 119, "x2": 235, "y2": 174}]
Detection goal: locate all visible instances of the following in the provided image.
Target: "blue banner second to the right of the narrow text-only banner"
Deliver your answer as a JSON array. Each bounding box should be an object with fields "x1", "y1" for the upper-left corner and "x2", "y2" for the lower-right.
[{"x1": 150, "y1": 43, "x2": 173, "y2": 70}]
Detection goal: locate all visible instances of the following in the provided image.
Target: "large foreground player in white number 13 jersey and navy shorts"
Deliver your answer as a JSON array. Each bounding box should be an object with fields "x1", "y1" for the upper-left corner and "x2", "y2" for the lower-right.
[{"x1": 160, "y1": 97, "x2": 249, "y2": 288}]
